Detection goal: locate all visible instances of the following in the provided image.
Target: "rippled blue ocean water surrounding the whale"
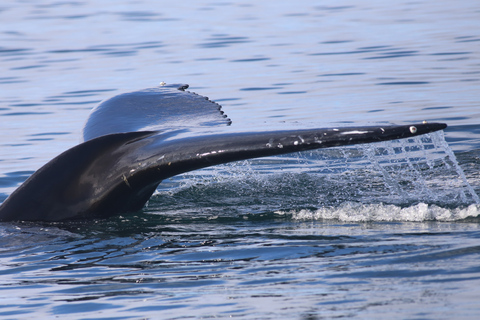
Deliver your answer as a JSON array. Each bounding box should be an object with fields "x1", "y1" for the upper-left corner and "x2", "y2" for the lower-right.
[{"x1": 0, "y1": 0, "x2": 480, "y2": 320}]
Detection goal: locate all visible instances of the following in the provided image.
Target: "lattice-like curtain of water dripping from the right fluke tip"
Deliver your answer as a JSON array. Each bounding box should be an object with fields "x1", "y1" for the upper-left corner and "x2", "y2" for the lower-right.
[{"x1": 363, "y1": 131, "x2": 480, "y2": 205}]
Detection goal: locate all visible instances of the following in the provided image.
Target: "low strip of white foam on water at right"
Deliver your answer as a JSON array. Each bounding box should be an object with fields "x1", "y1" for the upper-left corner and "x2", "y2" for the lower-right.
[{"x1": 284, "y1": 202, "x2": 480, "y2": 222}]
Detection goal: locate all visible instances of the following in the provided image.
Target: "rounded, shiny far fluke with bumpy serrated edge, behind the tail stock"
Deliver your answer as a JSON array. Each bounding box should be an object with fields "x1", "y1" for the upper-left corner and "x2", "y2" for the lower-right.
[{"x1": 83, "y1": 84, "x2": 232, "y2": 141}]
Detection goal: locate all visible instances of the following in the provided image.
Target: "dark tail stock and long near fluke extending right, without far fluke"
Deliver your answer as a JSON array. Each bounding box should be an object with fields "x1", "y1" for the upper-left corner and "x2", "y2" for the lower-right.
[{"x1": 0, "y1": 123, "x2": 446, "y2": 221}]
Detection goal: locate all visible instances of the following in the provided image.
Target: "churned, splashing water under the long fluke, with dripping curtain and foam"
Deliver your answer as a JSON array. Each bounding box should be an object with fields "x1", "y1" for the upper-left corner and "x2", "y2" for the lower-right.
[{"x1": 156, "y1": 132, "x2": 480, "y2": 221}]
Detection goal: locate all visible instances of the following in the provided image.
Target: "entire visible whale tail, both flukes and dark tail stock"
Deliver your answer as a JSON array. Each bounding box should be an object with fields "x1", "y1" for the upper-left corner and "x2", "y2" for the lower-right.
[{"x1": 0, "y1": 83, "x2": 447, "y2": 222}]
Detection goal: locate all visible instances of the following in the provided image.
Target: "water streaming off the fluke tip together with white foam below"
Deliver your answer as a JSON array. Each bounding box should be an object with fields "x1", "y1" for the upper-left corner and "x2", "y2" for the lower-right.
[{"x1": 284, "y1": 131, "x2": 480, "y2": 222}]
